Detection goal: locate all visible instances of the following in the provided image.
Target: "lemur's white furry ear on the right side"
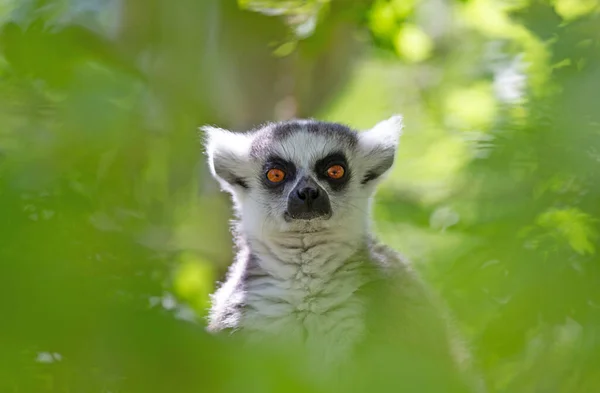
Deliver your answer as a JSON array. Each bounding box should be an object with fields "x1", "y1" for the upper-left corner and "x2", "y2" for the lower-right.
[{"x1": 358, "y1": 115, "x2": 404, "y2": 184}]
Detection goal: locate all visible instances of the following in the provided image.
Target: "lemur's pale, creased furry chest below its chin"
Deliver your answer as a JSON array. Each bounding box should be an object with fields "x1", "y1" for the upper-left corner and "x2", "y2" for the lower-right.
[{"x1": 242, "y1": 244, "x2": 369, "y2": 357}]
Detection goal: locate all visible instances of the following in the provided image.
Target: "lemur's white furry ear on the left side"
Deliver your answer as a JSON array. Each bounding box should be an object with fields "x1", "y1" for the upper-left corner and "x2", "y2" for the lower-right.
[{"x1": 200, "y1": 126, "x2": 252, "y2": 191}]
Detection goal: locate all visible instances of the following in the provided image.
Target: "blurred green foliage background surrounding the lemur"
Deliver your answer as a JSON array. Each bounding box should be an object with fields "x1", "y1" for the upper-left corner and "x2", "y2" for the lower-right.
[{"x1": 0, "y1": 0, "x2": 600, "y2": 393}]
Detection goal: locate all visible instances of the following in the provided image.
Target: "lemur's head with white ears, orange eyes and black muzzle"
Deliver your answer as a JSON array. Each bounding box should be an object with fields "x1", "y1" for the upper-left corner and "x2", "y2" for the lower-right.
[{"x1": 201, "y1": 116, "x2": 402, "y2": 236}]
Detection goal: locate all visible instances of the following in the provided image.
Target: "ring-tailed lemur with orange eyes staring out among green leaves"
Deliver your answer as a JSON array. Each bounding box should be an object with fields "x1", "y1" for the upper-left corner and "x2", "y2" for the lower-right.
[{"x1": 201, "y1": 116, "x2": 478, "y2": 386}]
